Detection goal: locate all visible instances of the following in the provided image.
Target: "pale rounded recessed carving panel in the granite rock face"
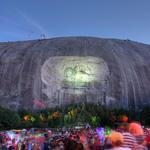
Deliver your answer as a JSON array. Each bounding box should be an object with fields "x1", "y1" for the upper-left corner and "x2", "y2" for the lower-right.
[{"x1": 41, "y1": 56, "x2": 109, "y2": 104}]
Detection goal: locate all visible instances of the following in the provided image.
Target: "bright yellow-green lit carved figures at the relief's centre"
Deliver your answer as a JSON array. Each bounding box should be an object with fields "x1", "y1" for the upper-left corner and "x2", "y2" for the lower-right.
[{"x1": 64, "y1": 61, "x2": 97, "y2": 88}]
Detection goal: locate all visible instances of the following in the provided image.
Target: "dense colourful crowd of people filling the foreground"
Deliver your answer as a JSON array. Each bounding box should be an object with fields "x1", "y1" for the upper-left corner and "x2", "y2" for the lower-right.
[{"x1": 0, "y1": 122, "x2": 150, "y2": 150}]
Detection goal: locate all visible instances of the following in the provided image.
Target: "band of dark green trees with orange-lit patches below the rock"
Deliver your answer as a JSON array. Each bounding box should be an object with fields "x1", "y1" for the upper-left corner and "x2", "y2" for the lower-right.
[{"x1": 0, "y1": 104, "x2": 150, "y2": 130}]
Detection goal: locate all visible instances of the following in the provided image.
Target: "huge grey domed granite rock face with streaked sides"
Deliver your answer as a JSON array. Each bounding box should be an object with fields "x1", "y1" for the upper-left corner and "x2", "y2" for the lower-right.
[{"x1": 0, "y1": 37, "x2": 150, "y2": 110}]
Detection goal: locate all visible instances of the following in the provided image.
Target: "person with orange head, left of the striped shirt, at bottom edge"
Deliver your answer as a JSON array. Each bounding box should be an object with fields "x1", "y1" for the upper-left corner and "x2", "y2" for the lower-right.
[{"x1": 110, "y1": 132, "x2": 131, "y2": 150}]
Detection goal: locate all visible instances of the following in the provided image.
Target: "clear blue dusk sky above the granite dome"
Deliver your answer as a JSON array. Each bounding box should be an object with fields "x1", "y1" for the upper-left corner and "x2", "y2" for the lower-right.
[{"x1": 0, "y1": 0, "x2": 150, "y2": 44}]
